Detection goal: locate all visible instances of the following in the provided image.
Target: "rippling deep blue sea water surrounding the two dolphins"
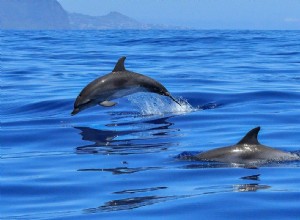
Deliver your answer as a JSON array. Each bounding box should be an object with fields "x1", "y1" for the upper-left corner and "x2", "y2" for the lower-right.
[{"x1": 0, "y1": 31, "x2": 300, "y2": 219}]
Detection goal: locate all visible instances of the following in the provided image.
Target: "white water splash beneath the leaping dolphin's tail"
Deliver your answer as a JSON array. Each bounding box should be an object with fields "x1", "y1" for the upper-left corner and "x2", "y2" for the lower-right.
[{"x1": 127, "y1": 93, "x2": 195, "y2": 115}]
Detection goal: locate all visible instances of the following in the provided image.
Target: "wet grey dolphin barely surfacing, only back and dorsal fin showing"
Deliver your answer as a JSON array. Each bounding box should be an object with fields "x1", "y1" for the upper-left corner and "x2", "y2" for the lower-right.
[{"x1": 195, "y1": 127, "x2": 300, "y2": 164}]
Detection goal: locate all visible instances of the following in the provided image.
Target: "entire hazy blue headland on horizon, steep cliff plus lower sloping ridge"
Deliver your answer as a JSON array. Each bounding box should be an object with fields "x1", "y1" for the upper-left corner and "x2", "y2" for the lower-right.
[{"x1": 0, "y1": 0, "x2": 183, "y2": 30}]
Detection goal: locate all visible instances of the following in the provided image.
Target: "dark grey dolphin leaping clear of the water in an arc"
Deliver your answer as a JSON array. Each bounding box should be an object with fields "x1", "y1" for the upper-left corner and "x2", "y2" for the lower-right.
[{"x1": 71, "y1": 57, "x2": 180, "y2": 115}]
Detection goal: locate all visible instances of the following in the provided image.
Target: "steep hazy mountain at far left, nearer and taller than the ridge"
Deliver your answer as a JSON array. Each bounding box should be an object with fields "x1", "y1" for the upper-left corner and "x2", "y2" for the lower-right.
[{"x1": 0, "y1": 0, "x2": 70, "y2": 30}]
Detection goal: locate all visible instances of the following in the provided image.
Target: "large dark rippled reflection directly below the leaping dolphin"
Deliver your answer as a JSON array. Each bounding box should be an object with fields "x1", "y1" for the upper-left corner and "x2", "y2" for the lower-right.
[{"x1": 75, "y1": 117, "x2": 178, "y2": 155}]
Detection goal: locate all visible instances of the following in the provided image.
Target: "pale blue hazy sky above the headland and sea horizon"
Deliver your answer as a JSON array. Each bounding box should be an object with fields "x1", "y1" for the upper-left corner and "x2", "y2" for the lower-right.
[{"x1": 58, "y1": 0, "x2": 300, "y2": 30}]
